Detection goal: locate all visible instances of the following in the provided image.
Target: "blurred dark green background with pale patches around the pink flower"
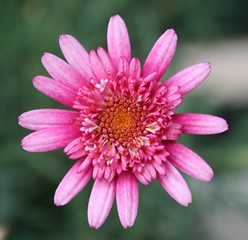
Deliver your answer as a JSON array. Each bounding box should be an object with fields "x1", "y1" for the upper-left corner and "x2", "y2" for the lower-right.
[{"x1": 0, "y1": 0, "x2": 248, "y2": 240}]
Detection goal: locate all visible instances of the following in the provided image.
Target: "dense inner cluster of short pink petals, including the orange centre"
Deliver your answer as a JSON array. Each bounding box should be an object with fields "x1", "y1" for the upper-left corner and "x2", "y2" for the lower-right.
[{"x1": 69, "y1": 52, "x2": 185, "y2": 184}]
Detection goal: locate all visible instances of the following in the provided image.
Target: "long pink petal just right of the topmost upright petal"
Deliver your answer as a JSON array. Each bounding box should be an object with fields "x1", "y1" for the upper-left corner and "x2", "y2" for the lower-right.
[{"x1": 142, "y1": 29, "x2": 177, "y2": 80}]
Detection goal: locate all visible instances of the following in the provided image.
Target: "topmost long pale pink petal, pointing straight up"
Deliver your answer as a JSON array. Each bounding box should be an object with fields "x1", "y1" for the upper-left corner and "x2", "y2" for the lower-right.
[{"x1": 107, "y1": 15, "x2": 131, "y2": 68}]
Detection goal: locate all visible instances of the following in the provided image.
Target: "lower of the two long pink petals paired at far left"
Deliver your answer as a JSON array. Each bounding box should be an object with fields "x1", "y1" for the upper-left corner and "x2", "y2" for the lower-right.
[{"x1": 22, "y1": 125, "x2": 80, "y2": 152}]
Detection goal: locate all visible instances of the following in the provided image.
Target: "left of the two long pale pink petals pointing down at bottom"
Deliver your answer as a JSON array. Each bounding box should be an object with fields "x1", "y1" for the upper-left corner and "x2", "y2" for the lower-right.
[{"x1": 88, "y1": 178, "x2": 116, "y2": 228}]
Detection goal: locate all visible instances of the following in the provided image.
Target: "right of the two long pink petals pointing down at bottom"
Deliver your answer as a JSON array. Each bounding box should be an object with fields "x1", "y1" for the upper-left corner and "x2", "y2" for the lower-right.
[{"x1": 116, "y1": 172, "x2": 139, "y2": 228}]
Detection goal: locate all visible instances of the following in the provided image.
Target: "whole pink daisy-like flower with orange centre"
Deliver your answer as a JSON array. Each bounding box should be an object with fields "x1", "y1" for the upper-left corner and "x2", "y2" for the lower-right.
[{"x1": 19, "y1": 15, "x2": 228, "y2": 228}]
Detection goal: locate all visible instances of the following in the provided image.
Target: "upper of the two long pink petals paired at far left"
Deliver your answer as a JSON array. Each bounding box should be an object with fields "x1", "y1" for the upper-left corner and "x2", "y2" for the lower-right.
[{"x1": 19, "y1": 109, "x2": 78, "y2": 130}]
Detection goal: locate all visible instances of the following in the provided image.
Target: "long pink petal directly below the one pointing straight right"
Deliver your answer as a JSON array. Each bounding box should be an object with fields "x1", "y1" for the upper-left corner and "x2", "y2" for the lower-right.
[{"x1": 165, "y1": 142, "x2": 214, "y2": 181}]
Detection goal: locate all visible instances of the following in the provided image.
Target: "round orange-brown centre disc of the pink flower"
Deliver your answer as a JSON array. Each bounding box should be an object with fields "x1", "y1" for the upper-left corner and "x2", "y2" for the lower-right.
[{"x1": 99, "y1": 98, "x2": 146, "y2": 147}]
